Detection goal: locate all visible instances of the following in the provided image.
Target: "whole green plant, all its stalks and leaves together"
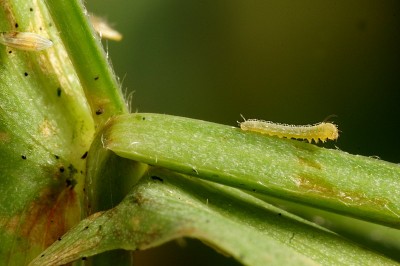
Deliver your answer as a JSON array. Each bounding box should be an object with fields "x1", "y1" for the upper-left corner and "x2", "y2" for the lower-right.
[{"x1": 0, "y1": 0, "x2": 400, "y2": 265}]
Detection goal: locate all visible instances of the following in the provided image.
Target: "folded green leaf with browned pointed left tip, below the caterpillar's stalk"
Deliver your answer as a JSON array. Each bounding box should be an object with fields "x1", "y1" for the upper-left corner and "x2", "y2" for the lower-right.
[{"x1": 31, "y1": 169, "x2": 395, "y2": 266}]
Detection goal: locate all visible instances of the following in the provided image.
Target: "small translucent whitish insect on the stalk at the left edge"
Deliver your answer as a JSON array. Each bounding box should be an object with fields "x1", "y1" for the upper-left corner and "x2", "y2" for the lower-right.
[{"x1": 0, "y1": 31, "x2": 53, "y2": 51}]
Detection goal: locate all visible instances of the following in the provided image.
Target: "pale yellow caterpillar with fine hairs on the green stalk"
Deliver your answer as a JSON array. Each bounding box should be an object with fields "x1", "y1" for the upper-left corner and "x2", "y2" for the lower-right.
[{"x1": 239, "y1": 119, "x2": 339, "y2": 143}]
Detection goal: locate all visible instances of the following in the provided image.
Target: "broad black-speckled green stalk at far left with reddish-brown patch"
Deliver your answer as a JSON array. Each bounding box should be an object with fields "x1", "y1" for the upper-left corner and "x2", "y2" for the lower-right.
[{"x1": 0, "y1": 1, "x2": 94, "y2": 265}]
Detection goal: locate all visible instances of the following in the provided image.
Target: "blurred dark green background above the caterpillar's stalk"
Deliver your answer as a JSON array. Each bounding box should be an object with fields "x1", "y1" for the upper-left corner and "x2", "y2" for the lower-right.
[{"x1": 86, "y1": 0, "x2": 400, "y2": 265}]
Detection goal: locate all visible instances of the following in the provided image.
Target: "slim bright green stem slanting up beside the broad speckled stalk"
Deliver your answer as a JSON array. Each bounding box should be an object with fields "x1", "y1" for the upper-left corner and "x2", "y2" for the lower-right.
[{"x1": 46, "y1": 0, "x2": 128, "y2": 125}]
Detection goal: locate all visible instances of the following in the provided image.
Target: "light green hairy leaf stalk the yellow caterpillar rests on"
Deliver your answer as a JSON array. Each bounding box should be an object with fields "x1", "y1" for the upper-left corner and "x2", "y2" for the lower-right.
[{"x1": 102, "y1": 114, "x2": 400, "y2": 228}]
